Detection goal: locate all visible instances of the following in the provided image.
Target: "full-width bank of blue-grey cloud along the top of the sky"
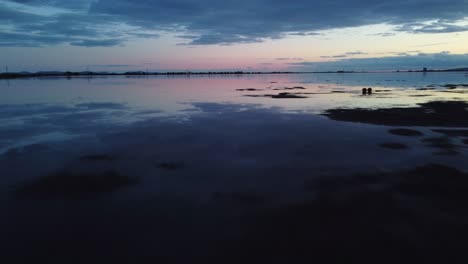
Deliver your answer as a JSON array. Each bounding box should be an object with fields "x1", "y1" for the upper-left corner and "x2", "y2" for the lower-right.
[{"x1": 0, "y1": 0, "x2": 468, "y2": 45}]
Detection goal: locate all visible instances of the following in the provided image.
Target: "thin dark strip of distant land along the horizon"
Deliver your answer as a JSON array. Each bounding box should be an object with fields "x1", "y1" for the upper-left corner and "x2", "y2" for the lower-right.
[{"x1": 0, "y1": 67, "x2": 468, "y2": 79}]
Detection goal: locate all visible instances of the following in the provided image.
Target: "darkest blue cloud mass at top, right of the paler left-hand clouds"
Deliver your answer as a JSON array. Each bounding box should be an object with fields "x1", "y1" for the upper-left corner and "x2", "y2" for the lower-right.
[{"x1": 90, "y1": 0, "x2": 468, "y2": 45}]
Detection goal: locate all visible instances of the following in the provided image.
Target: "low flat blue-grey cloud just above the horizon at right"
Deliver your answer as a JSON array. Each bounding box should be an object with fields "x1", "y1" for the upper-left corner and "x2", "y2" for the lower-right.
[{"x1": 289, "y1": 51, "x2": 468, "y2": 71}]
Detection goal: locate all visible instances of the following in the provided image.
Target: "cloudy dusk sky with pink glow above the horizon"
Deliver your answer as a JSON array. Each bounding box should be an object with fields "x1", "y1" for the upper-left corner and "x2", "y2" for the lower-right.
[{"x1": 0, "y1": 0, "x2": 468, "y2": 72}]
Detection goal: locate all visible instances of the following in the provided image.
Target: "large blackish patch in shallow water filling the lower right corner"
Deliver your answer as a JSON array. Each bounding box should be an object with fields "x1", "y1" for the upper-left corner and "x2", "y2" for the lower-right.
[{"x1": 236, "y1": 165, "x2": 468, "y2": 263}]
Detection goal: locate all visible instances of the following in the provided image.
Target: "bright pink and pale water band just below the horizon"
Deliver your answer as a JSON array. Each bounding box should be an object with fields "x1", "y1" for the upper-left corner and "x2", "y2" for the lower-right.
[{"x1": 0, "y1": 73, "x2": 468, "y2": 114}]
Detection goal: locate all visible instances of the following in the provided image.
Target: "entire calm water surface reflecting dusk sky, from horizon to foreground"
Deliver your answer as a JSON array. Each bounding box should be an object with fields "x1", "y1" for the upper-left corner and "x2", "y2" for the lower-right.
[{"x1": 0, "y1": 73, "x2": 468, "y2": 263}]
